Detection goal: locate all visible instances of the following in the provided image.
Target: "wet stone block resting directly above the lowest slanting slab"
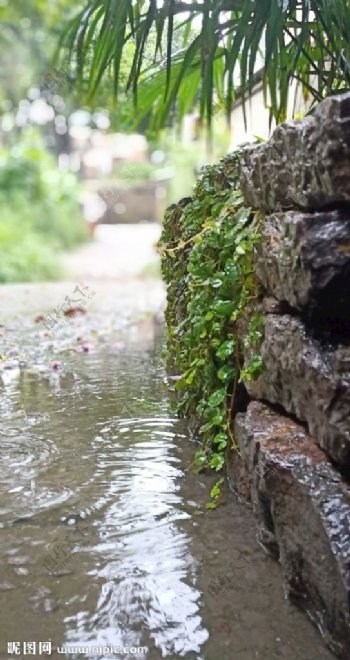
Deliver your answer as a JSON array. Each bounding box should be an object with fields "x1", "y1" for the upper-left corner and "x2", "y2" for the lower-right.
[{"x1": 247, "y1": 314, "x2": 350, "y2": 466}]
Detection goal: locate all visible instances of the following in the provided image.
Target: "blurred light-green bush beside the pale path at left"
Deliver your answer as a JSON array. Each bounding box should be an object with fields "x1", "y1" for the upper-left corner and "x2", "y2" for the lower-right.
[{"x1": 0, "y1": 133, "x2": 87, "y2": 282}]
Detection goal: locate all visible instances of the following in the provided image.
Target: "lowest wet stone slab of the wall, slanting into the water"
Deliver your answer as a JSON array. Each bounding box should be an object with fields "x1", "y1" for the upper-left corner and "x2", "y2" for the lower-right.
[{"x1": 230, "y1": 402, "x2": 350, "y2": 660}]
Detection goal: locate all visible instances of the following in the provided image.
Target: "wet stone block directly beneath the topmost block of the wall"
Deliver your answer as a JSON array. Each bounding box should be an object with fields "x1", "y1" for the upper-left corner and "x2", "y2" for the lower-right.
[{"x1": 255, "y1": 210, "x2": 350, "y2": 321}]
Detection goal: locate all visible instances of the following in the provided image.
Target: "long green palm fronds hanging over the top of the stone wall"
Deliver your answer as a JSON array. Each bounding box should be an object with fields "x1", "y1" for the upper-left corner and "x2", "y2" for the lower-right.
[{"x1": 60, "y1": 0, "x2": 350, "y2": 131}]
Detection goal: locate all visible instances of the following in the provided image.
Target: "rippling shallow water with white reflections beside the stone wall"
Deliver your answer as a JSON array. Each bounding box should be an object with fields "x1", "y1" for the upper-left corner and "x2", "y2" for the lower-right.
[{"x1": 0, "y1": 318, "x2": 331, "y2": 660}]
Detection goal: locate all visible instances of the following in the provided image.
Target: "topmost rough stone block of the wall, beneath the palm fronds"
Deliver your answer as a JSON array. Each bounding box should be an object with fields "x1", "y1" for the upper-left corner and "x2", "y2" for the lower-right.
[{"x1": 241, "y1": 93, "x2": 350, "y2": 213}]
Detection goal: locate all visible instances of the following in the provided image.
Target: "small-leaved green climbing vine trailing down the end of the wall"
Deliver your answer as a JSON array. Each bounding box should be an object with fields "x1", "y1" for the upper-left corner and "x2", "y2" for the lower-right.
[{"x1": 159, "y1": 151, "x2": 262, "y2": 490}]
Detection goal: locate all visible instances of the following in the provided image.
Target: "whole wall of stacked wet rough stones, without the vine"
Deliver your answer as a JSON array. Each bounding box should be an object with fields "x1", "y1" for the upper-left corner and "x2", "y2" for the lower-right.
[{"x1": 230, "y1": 93, "x2": 350, "y2": 660}]
